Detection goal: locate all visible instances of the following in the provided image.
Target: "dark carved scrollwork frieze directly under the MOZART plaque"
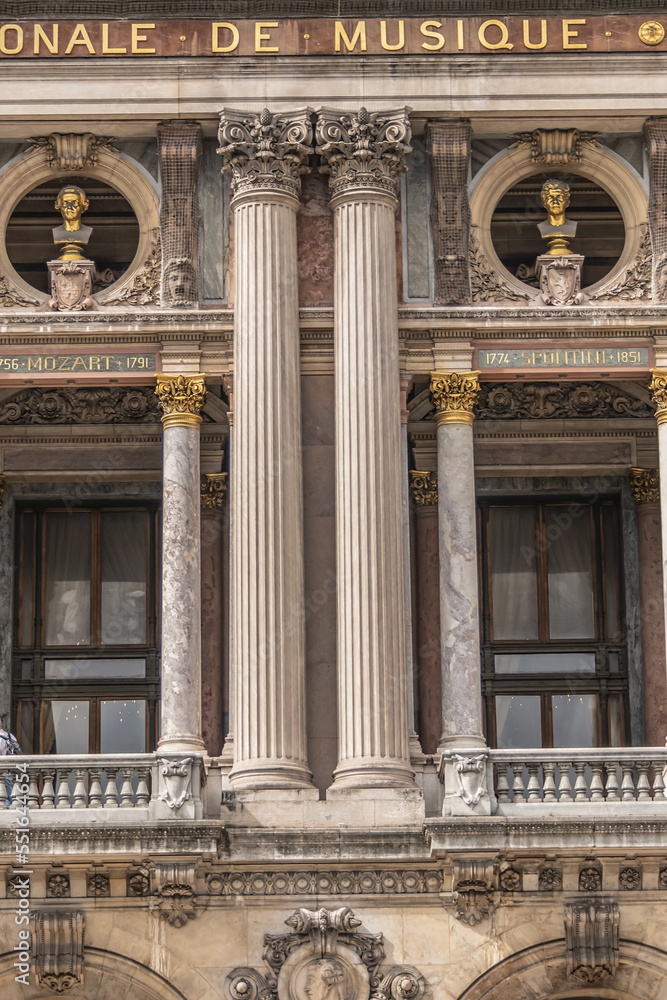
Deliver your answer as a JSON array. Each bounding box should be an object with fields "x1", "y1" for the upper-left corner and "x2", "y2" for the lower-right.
[{"x1": 0, "y1": 386, "x2": 160, "y2": 425}]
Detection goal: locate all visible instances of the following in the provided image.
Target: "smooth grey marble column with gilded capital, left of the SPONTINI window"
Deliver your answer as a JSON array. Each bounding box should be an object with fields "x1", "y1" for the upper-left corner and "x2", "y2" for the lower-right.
[{"x1": 431, "y1": 372, "x2": 485, "y2": 751}]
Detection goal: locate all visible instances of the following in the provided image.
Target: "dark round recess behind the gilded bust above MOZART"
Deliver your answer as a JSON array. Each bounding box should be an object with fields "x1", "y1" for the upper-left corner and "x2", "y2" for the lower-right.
[{"x1": 5, "y1": 176, "x2": 139, "y2": 293}]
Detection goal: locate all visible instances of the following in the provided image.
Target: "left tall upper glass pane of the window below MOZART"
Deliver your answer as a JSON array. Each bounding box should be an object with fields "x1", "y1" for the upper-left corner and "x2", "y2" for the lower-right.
[{"x1": 45, "y1": 512, "x2": 90, "y2": 646}]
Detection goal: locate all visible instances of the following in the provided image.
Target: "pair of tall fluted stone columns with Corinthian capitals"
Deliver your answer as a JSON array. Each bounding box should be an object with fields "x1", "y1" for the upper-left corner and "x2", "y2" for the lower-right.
[{"x1": 219, "y1": 103, "x2": 413, "y2": 788}]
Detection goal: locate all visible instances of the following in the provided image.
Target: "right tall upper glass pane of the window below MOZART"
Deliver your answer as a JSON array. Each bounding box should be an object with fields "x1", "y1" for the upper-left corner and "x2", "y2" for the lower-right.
[{"x1": 102, "y1": 511, "x2": 148, "y2": 646}]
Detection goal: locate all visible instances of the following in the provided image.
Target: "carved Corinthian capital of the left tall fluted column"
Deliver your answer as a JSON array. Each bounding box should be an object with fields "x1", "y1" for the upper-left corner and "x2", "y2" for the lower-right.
[{"x1": 218, "y1": 108, "x2": 313, "y2": 198}]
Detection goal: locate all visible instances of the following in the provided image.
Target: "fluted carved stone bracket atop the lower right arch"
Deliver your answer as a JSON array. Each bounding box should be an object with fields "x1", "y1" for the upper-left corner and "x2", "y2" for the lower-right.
[{"x1": 565, "y1": 902, "x2": 620, "y2": 985}]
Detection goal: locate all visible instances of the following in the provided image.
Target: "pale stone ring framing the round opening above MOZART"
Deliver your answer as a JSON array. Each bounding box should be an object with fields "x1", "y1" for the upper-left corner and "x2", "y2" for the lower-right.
[{"x1": 0, "y1": 147, "x2": 160, "y2": 302}]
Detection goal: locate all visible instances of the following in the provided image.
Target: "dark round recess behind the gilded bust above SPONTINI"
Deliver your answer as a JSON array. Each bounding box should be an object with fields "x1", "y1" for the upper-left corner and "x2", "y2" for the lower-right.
[{"x1": 490, "y1": 171, "x2": 625, "y2": 288}]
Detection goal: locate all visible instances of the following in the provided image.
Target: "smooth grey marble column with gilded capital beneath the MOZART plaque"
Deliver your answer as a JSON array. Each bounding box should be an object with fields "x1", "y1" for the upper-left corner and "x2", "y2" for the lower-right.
[{"x1": 155, "y1": 375, "x2": 206, "y2": 753}]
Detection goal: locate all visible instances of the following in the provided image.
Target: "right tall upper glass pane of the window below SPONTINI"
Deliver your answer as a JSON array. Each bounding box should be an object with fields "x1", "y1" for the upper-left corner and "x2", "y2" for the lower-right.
[{"x1": 546, "y1": 506, "x2": 595, "y2": 639}]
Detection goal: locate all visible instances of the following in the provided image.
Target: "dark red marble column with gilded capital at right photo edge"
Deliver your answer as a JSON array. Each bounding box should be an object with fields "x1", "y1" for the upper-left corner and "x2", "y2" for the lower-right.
[{"x1": 630, "y1": 469, "x2": 667, "y2": 746}]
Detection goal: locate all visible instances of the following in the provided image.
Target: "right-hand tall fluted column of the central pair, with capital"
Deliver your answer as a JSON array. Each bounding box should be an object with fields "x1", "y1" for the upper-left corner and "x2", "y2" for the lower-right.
[{"x1": 317, "y1": 108, "x2": 414, "y2": 788}]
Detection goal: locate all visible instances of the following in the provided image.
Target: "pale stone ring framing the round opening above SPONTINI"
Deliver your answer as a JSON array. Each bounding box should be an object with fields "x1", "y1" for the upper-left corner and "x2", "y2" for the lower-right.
[{"x1": 469, "y1": 143, "x2": 648, "y2": 298}]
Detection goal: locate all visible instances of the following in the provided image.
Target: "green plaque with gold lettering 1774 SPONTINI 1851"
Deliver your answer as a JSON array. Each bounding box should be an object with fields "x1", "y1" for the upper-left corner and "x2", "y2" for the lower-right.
[{"x1": 475, "y1": 347, "x2": 650, "y2": 373}]
